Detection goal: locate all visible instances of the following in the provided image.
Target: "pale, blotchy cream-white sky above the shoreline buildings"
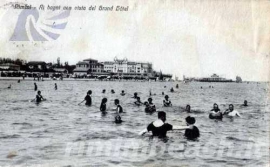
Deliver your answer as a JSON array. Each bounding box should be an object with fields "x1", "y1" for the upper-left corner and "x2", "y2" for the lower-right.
[{"x1": 0, "y1": 0, "x2": 270, "y2": 81}]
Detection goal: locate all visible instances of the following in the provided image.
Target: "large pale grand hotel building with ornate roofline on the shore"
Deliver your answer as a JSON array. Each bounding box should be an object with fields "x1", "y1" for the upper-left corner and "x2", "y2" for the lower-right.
[{"x1": 102, "y1": 58, "x2": 153, "y2": 74}]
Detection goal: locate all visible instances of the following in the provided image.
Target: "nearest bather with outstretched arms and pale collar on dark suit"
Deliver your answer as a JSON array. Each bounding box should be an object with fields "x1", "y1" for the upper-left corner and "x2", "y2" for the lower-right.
[{"x1": 139, "y1": 111, "x2": 192, "y2": 138}]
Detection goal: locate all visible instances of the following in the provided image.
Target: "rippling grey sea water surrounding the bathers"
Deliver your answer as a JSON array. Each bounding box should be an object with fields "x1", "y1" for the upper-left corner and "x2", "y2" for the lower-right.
[{"x1": 0, "y1": 80, "x2": 269, "y2": 167}]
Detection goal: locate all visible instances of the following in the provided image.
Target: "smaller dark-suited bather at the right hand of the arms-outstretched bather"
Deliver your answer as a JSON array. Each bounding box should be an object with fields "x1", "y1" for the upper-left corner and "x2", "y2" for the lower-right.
[{"x1": 184, "y1": 116, "x2": 200, "y2": 140}]
